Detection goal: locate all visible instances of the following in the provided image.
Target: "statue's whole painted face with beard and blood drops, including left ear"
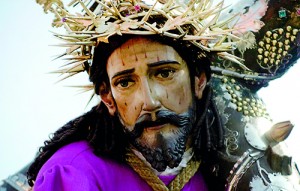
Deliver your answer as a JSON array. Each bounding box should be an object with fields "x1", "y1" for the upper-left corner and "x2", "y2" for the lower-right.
[{"x1": 101, "y1": 37, "x2": 202, "y2": 171}]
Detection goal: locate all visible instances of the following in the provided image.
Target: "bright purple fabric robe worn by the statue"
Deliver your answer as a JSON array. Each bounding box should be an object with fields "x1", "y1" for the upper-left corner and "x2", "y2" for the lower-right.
[{"x1": 34, "y1": 141, "x2": 207, "y2": 191}]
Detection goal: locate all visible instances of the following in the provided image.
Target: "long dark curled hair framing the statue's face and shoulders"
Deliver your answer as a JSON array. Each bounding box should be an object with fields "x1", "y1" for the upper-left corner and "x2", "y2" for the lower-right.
[{"x1": 27, "y1": 35, "x2": 223, "y2": 186}]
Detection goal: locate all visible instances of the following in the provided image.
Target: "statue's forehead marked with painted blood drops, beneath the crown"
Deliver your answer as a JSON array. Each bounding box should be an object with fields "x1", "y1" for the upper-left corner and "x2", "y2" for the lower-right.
[{"x1": 107, "y1": 37, "x2": 182, "y2": 76}]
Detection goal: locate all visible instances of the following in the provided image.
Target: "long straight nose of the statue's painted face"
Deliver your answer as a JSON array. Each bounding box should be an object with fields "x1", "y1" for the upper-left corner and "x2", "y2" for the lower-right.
[{"x1": 141, "y1": 79, "x2": 161, "y2": 112}]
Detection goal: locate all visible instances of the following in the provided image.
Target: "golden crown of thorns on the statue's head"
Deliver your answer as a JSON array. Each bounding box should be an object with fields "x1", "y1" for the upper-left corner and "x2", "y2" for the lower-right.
[{"x1": 37, "y1": 0, "x2": 246, "y2": 92}]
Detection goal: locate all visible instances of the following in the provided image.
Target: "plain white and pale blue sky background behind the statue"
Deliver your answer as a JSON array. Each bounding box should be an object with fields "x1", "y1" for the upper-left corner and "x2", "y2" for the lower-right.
[{"x1": 0, "y1": 0, "x2": 300, "y2": 180}]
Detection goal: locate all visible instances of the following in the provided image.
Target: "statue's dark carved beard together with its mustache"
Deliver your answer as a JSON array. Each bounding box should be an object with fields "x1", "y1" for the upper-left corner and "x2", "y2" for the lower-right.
[{"x1": 125, "y1": 109, "x2": 194, "y2": 172}]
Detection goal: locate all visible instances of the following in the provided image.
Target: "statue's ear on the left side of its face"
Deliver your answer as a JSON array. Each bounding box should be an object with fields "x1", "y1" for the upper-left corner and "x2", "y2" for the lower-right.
[{"x1": 99, "y1": 83, "x2": 116, "y2": 116}]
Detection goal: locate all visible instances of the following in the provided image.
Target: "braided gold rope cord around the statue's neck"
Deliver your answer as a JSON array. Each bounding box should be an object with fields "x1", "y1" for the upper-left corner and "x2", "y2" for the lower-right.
[{"x1": 126, "y1": 151, "x2": 200, "y2": 191}]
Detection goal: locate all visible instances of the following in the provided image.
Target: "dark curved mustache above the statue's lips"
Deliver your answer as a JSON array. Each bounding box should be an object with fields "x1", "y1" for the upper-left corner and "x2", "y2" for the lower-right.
[{"x1": 126, "y1": 110, "x2": 191, "y2": 139}]
